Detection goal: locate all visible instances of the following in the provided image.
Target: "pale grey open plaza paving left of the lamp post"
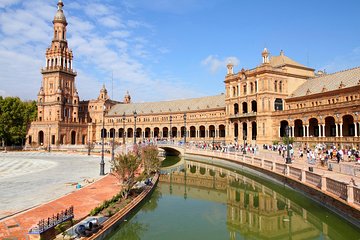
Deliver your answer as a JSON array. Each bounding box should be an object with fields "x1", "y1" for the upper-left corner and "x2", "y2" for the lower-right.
[{"x1": 0, "y1": 152, "x2": 110, "y2": 220}]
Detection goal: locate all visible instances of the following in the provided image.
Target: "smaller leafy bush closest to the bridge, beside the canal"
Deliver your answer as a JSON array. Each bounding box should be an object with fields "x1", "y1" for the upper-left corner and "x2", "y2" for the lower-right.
[{"x1": 141, "y1": 145, "x2": 161, "y2": 175}]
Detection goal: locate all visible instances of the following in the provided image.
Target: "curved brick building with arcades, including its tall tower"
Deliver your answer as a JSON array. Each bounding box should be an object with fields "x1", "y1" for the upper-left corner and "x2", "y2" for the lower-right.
[{"x1": 26, "y1": 0, "x2": 360, "y2": 148}]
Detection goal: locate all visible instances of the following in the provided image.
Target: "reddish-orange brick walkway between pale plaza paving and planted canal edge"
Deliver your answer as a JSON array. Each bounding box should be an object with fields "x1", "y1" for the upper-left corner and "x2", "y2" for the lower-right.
[{"x1": 0, "y1": 175, "x2": 120, "y2": 240}]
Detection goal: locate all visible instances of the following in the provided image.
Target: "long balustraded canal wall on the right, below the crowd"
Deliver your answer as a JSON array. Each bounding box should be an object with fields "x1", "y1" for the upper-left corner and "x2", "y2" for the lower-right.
[{"x1": 186, "y1": 150, "x2": 360, "y2": 227}]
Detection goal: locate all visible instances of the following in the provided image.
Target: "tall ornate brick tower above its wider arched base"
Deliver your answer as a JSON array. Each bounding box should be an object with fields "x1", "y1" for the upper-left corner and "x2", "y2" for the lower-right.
[{"x1": 37, "y1": 0, "x2": 79, "y2": 122}]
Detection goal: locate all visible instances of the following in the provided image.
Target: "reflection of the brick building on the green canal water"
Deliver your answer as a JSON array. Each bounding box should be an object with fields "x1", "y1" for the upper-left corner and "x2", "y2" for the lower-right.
[{"x1": 160, "y1": 160, "x2": 359, "y2": 240}]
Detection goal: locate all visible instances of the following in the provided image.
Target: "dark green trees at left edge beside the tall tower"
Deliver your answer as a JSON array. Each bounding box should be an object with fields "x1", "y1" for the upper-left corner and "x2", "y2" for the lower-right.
[{"x1": 0, "y1": 97, "x2": 37, "y2": 145}]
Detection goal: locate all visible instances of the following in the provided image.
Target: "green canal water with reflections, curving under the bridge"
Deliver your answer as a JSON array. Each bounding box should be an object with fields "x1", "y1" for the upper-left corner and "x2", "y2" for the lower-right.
[{"x1": 108, "y1": 158, "x2": 360, "y2": 240}]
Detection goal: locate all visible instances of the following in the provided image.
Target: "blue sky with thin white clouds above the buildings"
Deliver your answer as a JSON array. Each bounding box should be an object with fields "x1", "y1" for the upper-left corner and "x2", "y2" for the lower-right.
[{"x1": 0, "y1": 0, "x2": 360, "y2": 102}]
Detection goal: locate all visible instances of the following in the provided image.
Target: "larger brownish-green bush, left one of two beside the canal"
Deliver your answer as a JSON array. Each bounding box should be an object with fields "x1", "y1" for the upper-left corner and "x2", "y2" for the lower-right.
[{"x1": 111, "y1": 152, "x2": 141, "y2": 198}]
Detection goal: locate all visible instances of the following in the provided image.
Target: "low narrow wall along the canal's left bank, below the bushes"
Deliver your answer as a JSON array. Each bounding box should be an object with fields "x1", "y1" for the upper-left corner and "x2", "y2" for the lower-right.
[{"x1": 84, "y1": 174, "x2": 159, "y2": 240}]
